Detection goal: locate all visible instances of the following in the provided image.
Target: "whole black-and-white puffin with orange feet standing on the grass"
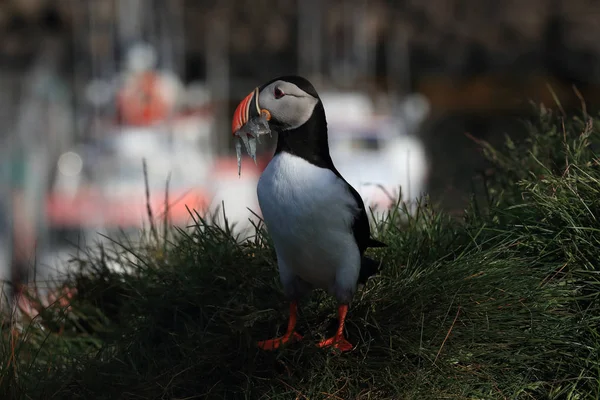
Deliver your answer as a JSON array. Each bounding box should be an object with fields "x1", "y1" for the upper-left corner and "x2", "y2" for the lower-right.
[{"x1": 232, "y1": 75, "x2": 386, "y2": 352}]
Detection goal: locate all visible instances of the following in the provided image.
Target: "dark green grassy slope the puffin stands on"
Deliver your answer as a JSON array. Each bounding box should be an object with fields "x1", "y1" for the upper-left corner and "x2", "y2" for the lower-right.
[{"x1": 0, "y1": 104, "x2": 600, "y2": 399}]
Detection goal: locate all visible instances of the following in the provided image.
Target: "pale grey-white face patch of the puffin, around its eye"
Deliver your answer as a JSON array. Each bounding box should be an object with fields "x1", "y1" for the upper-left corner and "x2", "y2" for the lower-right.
[{"x1": 258, "y1": 81, "x2": 319, "y2": 131}]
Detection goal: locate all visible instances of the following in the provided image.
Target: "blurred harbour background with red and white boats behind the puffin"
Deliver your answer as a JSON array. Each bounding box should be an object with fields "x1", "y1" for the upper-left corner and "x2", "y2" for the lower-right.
[{"x1": 0, "y1": 0, "x2": 600, "y2": 294}]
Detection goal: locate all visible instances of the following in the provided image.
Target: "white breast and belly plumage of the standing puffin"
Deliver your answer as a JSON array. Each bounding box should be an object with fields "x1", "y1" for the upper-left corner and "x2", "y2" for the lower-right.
[{"x1": 257, "y1": 152, "x2": 360, "y2": 290}]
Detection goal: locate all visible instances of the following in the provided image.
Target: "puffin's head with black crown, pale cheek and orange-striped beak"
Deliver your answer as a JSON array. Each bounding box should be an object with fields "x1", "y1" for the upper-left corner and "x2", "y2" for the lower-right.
[{"x1": 231, "y1": 76, "x2": 321, "y2": 134}]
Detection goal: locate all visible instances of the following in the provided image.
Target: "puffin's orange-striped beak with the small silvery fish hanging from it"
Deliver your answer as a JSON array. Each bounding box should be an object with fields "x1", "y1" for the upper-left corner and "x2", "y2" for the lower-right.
[{"x1": 231, "y1": 88, "x2": 271, "y2": 176}]
